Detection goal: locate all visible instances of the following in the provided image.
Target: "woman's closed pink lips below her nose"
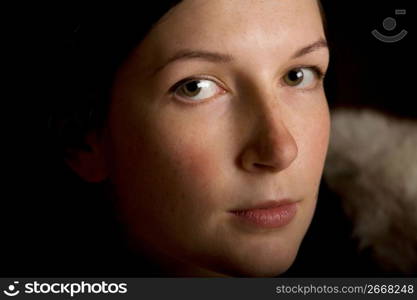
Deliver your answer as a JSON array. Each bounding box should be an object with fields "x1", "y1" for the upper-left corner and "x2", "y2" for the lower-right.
[{"x1": 231, "y1": 199, "x2": 297, "y2": 228}]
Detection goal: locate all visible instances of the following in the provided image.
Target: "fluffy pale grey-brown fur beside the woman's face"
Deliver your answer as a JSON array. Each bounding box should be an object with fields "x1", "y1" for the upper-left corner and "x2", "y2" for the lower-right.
[{"x1": 323, "y1": 109, "x2": 417, "y2": 273}]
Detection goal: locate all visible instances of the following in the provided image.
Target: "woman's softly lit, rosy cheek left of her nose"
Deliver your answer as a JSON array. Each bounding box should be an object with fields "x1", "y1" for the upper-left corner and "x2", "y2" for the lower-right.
[{"x1": 155, "y1": 110, "x2": 231, "y2": 189}]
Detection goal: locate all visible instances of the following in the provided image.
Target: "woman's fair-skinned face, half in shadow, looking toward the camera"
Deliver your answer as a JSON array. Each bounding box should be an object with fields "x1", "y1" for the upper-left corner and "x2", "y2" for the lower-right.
[{"x1": 98, "y1": 0, "x2": 329, "y2": 276}]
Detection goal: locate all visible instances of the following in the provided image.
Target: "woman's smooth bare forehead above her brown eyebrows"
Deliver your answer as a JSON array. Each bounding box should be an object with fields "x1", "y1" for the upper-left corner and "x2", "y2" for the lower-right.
[{"x1": 130, "y1": 0, "x2": 324, "y2": 71}]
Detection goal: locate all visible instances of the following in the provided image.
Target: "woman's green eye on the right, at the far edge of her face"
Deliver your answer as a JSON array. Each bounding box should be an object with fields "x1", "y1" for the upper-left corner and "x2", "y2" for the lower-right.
[{"x1": 284, "y1": 67, "x2": 322, "y2": 89}]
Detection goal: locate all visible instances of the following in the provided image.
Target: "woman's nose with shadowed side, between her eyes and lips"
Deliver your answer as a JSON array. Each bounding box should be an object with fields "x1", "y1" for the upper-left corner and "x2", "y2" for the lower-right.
[{"x1": 240, "y1": 102, "x2": 298, "y2": 172}]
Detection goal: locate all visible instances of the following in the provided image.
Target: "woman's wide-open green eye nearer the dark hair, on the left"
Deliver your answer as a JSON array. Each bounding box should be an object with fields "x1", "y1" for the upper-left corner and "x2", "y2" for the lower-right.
[{"x1": 174, "y1": 79, "x2": 223, "y2": 101}]
